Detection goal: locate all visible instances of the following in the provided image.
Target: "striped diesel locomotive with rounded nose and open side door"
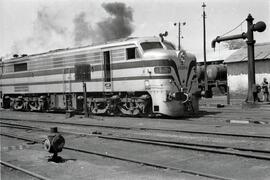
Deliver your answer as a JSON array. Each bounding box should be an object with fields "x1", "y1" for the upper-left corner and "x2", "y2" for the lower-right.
[{"x1": 0, "y1": 37, "x2": 200, "y2": 117}]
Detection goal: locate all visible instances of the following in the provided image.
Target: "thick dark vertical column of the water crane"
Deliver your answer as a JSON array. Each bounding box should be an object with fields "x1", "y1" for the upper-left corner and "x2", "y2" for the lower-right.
[{"x1": 246, "y1": 14, "x2": 256, "y2": 102}]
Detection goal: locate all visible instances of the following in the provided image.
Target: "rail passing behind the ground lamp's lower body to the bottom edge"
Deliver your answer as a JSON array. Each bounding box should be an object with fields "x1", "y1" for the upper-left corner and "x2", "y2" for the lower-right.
[{"x1": 0, "y1": 132, "x2": 232, "y2": 180}]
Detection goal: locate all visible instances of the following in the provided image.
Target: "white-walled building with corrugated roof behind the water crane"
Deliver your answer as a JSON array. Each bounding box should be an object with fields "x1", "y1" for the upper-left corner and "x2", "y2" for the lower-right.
[{"x1": 224, "y1": 42, "x2": 270, "y2": 97}]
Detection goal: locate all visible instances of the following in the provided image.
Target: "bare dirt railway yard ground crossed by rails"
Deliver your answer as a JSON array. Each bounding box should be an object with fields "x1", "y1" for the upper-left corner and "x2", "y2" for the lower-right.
[{"x1": 0, "y1": 97, "x2": 270, "y2": 180}]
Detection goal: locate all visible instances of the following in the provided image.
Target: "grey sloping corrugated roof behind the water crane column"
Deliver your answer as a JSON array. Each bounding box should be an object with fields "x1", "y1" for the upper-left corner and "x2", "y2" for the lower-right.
[{"x1": 224, "y1": 42, "x2": 270, "y2": 63}]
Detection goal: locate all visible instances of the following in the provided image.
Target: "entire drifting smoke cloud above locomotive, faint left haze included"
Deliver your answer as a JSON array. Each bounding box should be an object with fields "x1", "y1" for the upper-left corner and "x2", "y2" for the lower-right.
[{"x1": 11, "y1": 2, "x2": 133, "y2": 54}]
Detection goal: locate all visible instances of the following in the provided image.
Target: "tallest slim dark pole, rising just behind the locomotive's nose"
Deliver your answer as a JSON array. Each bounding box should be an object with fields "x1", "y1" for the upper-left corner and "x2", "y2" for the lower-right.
[{"x1": 202, "y1": 3, "x2": 208, "y2": 93}]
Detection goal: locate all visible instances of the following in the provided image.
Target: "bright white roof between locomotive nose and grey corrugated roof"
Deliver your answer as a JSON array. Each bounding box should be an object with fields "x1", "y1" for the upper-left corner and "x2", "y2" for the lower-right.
[{"x1": 197, "y1": 50, "x2": 237, "y2": 62}]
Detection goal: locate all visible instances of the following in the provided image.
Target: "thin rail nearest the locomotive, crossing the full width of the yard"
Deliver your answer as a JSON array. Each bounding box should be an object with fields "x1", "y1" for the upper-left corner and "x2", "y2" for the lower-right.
[{"x1": 0, "y1": 118, "x2": 270, "y2": 139}]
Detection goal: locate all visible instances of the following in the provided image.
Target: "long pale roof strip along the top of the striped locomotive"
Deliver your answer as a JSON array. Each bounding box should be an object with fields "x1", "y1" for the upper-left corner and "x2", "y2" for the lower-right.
[{"x1": 3, "y1": 36, "x2": 160, "y2": 63}]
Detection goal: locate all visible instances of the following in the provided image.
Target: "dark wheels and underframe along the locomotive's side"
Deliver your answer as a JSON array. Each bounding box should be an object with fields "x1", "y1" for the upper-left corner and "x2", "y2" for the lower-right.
[{"x1": 3, "y1": 91, "x2": 152, "y2": 115}]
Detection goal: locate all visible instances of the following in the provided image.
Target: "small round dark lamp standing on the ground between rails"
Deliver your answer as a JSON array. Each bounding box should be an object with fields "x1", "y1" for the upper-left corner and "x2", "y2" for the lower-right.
[{"x1": 44, "y1": 127, "x2": 65, "y2": 162}]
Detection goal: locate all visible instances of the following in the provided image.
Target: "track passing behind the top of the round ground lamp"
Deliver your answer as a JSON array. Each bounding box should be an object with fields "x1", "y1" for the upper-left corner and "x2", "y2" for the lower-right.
[{"x1": 0, "y1": 122, "x2": 270, "y2": 160}]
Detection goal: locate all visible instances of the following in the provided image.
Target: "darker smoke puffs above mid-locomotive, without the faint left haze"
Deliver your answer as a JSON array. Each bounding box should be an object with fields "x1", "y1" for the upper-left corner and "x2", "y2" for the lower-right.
[{"x1": 73, "y1": 2, "x2": 134, "y2": 45}]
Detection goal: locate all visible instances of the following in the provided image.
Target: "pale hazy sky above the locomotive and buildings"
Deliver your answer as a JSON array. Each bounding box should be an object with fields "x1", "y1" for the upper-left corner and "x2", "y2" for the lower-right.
[{"x1": 0, "y1": 0, "x2": 270, "y2": 57}]
